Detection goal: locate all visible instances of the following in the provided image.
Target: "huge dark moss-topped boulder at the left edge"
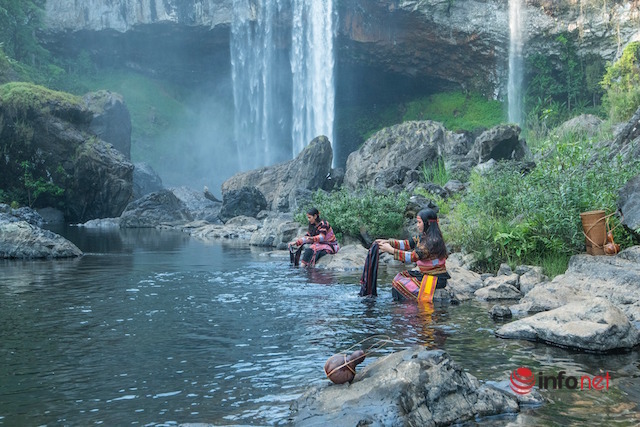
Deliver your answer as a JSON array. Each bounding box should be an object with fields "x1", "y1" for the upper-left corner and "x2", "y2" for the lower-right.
[{"x1": 0, "y1": 83, "x2": 133, "y2": 222}]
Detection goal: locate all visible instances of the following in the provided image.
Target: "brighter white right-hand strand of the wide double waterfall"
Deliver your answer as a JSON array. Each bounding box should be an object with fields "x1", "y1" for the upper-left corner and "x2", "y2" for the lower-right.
[{"x1": 291, "y1": 0, "x2": 335, "y2": 156}]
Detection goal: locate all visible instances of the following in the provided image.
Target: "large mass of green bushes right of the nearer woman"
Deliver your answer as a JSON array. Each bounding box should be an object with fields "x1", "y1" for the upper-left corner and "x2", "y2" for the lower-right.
[{"x1": 445, "y1": 129, "x2": 640, "y2": 275}]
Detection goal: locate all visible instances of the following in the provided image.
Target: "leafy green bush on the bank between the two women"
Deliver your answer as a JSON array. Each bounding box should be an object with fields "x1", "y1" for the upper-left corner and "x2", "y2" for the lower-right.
[{"x1": 296, "y1": 189, "x2": 409, "y2": 239}]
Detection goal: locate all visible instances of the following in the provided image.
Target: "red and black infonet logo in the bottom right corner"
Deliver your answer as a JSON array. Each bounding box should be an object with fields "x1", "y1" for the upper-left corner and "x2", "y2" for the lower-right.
[{"x1": 509, "y1": 367, "x2": 611, "y2": 394}]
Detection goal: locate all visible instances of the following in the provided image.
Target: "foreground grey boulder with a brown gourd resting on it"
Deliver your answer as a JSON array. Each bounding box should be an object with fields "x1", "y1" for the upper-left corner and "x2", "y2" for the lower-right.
[{"x1": 292, "y1": 347, "x2": 520, "y2": 426}]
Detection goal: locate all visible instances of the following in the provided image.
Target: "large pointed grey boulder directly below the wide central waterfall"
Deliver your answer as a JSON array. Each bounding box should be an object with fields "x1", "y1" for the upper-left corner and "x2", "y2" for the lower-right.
[{"x1": 222, "y1": 136, "x2": 333, "y2": 212}]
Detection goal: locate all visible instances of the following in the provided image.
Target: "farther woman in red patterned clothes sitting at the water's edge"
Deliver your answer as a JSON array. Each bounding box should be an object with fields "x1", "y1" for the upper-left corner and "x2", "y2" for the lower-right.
[{"x1": 289, "y1": 208, "x2": 340, "y2": 267}]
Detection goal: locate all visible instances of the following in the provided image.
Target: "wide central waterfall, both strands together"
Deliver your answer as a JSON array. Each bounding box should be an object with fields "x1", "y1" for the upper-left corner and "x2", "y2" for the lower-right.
[{"x1": 230, "y1": 0, "x2": 335, "y2": 170}]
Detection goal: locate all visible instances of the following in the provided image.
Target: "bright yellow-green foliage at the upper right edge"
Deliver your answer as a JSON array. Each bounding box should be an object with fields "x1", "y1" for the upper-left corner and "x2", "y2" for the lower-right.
[{"x1": 601, "y1": 42, "x2": 640, "y2": 121}]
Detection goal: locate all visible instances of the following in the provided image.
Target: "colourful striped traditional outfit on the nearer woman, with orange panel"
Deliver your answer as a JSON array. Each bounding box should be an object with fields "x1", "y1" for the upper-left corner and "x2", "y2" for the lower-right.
[{"x1": 389, "y1": 236, "x2": 451, "y2": 302}]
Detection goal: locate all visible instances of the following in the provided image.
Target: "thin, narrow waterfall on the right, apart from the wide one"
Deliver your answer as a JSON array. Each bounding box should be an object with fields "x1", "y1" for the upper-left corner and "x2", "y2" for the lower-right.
[{"x1": 507, "y1": 0, "x2": 524, "y2": 125}]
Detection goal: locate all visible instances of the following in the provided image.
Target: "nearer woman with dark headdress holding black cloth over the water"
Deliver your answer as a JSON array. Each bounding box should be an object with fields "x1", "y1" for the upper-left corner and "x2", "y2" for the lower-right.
[{"x1": 376, "y1": 209, "x2": 451, "y2": 302}]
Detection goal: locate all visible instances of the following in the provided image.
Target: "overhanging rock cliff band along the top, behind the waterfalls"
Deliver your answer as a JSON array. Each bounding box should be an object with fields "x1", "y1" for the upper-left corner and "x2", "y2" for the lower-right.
[{"x1": 44, "y1": 0, "x2": 640, "y2": 96}]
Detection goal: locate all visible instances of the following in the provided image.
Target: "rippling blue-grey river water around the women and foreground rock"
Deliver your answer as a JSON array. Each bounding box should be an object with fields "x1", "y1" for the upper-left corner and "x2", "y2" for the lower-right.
[{"x1": 0, "y1": 227, "x2": 640, "y2": 426}]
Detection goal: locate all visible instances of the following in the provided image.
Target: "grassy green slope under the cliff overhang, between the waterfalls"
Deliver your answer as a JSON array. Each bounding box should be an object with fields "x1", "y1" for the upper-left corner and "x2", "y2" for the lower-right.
[{"x1": 403, "y1": 92, "x2": 506, "y2": 131}]
